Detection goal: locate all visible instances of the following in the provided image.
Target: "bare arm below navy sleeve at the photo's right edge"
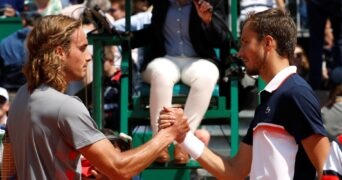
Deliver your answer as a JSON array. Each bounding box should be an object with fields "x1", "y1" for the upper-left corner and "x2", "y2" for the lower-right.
[{"x1": 302, "y1": 134, "x2": 330, "y2": 179}]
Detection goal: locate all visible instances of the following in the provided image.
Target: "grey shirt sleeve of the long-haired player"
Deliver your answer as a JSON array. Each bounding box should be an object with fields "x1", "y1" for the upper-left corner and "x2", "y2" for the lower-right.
[{"x1": 58, "y1": 97, "x2": 105, "y2": 149}]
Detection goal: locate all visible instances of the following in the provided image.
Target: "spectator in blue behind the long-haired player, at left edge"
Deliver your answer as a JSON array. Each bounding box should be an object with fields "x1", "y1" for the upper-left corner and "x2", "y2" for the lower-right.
[{"x1": 0, "y1": 12, "x2": 41, "y2": 91}]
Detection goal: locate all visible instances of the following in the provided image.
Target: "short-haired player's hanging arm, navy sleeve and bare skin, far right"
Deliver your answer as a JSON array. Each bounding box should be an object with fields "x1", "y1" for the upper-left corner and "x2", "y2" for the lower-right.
[{"x1": 289, "y1": 87, "x2": 330, "y2": 179}]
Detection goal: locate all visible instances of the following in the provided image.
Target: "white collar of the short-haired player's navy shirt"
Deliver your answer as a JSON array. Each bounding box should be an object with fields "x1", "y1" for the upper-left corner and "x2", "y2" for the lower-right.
[{"x1": 264, "y1": 66, "x2": 297, "y2": 93}]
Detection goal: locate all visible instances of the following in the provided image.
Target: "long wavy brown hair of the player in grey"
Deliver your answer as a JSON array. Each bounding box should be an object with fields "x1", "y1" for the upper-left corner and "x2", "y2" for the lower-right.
[{"x1": 23, "y1": 15, "x2": 82, "y2": 92}]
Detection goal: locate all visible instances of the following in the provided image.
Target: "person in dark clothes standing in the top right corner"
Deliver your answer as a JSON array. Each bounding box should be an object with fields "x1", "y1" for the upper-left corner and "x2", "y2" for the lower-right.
[{"x1": 307, "y1": 0, "x2": 342, "y2": 89}]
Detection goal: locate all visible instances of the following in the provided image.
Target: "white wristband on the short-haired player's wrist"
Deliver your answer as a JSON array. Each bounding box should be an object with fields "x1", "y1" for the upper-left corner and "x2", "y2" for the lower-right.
[{"x1": 180, "y1": 132, "x2": 205, "y2": 159}]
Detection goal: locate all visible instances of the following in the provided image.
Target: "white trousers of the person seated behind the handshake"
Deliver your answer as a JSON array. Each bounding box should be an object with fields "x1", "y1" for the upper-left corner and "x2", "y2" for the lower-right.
[{"x1": 142, "y1": 56, "x2": 219, "y2": 133}]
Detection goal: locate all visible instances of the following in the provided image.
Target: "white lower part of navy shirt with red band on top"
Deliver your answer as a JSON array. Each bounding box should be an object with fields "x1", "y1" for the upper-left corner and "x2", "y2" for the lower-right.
[{"x1": 250, "y1": 123, "x2": 298, "y2": 180}]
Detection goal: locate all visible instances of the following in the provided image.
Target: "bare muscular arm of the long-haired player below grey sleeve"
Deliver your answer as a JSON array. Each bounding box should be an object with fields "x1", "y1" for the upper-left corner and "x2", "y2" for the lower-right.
[{"x1": 79, "y1": 130, "x2": 174, "y2": 179}]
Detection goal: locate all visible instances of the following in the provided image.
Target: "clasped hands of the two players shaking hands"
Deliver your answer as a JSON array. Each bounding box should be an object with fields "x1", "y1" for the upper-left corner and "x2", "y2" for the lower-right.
[{"x1": 159, "y1": 107, "x2": 190, "y2": 143}]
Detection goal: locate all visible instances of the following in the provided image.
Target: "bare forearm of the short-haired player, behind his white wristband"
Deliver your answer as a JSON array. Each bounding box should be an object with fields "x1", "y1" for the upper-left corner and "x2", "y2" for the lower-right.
[{"x1": 197, "y1": 143, "x2": 252, "y2": 180}]
